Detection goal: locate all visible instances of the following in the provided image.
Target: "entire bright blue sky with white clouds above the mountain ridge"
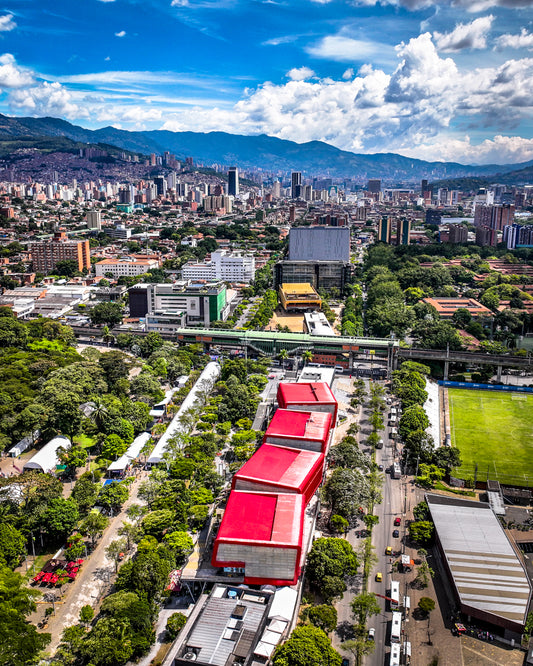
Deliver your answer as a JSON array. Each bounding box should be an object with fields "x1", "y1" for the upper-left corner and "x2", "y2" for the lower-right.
[{"x1": 0, "y1": 0, "x2": 533, "y2": 163}]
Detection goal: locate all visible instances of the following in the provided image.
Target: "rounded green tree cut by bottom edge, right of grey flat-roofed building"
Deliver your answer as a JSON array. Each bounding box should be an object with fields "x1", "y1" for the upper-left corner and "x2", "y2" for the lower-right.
[{"x1": 272, "y1": 626, "x2": 342, "y2": 666}]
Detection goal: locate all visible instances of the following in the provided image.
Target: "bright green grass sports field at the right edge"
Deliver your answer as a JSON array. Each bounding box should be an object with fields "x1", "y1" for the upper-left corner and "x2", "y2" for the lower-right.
[{"x1": 448, "y1": 389, "x2": 533, "y2": 485}]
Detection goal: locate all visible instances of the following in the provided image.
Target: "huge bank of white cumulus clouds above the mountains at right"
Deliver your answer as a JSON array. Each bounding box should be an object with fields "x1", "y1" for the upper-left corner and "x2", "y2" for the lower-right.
[{"x1": 159, "y1": 33, "x2": 533, "y2": 163}]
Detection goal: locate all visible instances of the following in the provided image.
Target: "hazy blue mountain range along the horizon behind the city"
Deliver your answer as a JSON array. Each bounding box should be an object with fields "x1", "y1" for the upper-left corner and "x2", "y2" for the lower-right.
[{"x1": 0, "y1": 114, "x2": 533, "y2": 184}]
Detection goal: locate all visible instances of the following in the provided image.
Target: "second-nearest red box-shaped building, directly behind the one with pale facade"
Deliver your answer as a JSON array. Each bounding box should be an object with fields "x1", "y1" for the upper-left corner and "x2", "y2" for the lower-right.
[{"x1": 232, "y1": 444, "x2": 324, "y2": 504}]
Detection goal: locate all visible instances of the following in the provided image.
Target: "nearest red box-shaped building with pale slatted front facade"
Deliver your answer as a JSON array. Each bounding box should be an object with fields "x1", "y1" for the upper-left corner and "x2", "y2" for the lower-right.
[{"x1": 211, "y1": 490, "x2": 305, "y2": 585}]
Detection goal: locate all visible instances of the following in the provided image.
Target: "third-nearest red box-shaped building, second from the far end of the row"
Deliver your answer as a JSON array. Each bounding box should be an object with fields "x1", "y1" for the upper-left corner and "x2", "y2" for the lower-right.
[{"x1": 263, "y1": 409, "x2": 331, "y2": 453}]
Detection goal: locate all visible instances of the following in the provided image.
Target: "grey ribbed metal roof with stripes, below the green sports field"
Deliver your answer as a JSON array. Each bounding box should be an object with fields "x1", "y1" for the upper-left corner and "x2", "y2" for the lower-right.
[{"x1": 426, "y1": 495, "x2": 531, "y2": 625}]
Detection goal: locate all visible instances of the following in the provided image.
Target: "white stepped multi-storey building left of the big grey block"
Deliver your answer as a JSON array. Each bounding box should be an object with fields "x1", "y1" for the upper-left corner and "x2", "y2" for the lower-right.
[{"x1": 182, "y1": 250, "x2": 255, "y2": 284}]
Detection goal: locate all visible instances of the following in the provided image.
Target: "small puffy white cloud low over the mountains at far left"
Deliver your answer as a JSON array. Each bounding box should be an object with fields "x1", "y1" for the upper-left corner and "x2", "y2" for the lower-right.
[{"x1": 9, "y1": 81, "x2": 89, "y2": 120}]
